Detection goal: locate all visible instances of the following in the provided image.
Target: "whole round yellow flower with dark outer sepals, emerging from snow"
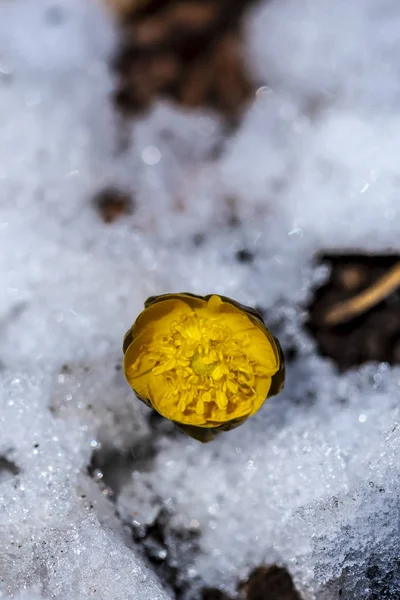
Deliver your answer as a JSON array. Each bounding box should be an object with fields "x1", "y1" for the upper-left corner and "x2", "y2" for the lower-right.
[{"x1": 123, "y1": 294, "x2": 285, "y2": 441}]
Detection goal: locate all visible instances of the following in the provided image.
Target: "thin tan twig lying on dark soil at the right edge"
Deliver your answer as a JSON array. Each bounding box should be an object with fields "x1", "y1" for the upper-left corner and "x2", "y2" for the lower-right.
[{"x1": 324, "y1": 261, "x2": 400, "y2": 327}]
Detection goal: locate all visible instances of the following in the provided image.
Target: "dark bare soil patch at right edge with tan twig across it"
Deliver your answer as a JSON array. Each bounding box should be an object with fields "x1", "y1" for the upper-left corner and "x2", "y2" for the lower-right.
[{"x1": 308, "y1": 254, "x2": 400, "y2": 370}]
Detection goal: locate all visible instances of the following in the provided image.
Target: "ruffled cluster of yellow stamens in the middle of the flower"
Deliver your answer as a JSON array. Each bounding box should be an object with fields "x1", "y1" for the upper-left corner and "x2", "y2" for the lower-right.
[{"x1": 148, "y1": 313, "x2": 261, "y2": 422}]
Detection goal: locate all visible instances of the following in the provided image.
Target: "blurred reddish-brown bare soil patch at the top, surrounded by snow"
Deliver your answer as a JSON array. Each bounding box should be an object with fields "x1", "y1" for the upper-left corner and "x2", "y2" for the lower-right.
[{"x1": 108, "y1": 0, "x2": 255, "y2": 122}]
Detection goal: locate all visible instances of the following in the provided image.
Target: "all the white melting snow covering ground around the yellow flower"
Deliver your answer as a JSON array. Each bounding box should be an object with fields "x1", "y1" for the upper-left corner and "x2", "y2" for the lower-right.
[{"x1": 0, "y1": 0, "x2": 400, "y2": 600}]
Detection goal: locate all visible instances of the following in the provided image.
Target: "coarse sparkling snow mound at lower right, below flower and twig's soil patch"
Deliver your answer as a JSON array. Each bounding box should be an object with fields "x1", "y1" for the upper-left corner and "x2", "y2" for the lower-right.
[{"x1": 123, "y1": 359, "x2": 400, "y2": 598}]
